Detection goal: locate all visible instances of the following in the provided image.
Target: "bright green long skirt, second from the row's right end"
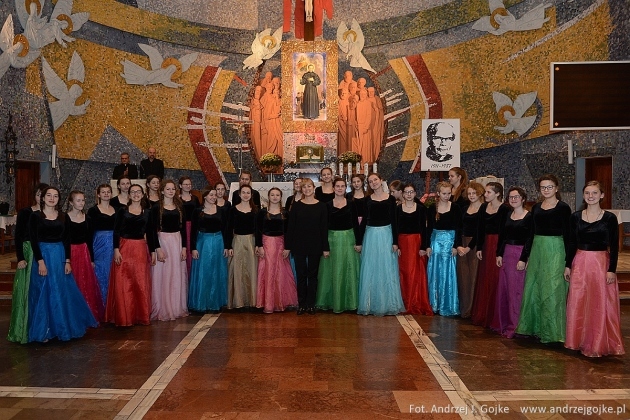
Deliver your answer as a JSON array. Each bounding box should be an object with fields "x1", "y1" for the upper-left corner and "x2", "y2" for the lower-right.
[{"x1": 516, "y1": 235, "x2": 569, "y2": 343}]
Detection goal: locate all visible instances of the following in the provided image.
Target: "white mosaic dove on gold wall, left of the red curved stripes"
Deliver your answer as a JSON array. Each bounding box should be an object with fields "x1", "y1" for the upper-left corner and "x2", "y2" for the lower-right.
[{"x1": 120, "y1": 44, "x2": 199, "y2": 88}]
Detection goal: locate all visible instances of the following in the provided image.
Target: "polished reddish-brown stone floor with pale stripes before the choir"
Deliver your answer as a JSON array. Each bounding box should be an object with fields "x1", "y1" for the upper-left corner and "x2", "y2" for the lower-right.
[{"x1": 0, "y1": 302, "x2": 630, "y2": 420}]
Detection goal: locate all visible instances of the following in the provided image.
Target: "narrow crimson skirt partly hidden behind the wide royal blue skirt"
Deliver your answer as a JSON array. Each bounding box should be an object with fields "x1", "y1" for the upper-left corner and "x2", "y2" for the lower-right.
[{"x1": 70, "y1": 243, "x2": 105, "y2": 322}]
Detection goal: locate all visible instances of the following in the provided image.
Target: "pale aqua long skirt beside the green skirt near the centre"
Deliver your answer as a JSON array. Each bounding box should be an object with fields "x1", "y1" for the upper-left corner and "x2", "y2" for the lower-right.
[{"x1": 357, "y1": 225, "x2": 405, "y2": 315}]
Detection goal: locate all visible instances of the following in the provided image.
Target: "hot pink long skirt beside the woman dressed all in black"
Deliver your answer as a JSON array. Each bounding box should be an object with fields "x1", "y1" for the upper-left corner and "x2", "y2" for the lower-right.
[{"x1": 256, "y1": 235, "x2": 298, "y2": 313}]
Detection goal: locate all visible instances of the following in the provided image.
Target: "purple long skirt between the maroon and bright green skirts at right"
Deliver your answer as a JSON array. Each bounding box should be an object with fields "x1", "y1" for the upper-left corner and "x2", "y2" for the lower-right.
[{"x1": 490, "y1": 244, "x2": 525, "y2": 338}]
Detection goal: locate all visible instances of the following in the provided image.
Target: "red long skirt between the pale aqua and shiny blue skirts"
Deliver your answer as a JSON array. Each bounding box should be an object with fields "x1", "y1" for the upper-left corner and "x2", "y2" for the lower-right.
[{"x1": 398, "y1": 233, "x2": 433, "y2": 315}]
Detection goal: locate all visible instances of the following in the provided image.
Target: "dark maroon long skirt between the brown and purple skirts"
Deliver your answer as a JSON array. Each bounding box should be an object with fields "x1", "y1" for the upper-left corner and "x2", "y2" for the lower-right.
[{"x1": 471, "y1": 234, "x2": 499, "y2": 328}]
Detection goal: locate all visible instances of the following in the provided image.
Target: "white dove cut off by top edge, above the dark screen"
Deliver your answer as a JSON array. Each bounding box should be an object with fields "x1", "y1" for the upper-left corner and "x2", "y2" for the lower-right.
[{"x1": 472, "y1": 0, "x2": 551, "y2": 35}]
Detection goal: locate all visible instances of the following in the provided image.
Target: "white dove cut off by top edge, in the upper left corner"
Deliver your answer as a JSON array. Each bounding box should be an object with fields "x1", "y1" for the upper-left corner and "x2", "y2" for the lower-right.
[{"x1": 15, "y1": 0, "x2": 90, "y2": 49}]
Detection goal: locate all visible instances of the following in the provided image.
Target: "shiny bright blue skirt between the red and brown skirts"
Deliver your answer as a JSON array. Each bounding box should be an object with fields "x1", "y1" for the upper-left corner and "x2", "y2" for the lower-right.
[{"x1": 427, "y1": 230, "x2": 459, "y2": 316}]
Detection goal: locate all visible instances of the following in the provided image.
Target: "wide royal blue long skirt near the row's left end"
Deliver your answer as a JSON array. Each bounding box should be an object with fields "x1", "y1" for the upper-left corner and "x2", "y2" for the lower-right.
[{"x1": 28, "y1": 242, "x2": 98, "y2": 341}]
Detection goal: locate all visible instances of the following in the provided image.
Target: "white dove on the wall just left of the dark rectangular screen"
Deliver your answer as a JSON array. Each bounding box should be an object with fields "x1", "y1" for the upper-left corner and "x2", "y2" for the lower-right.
[{"x1": 492, "y1": 92, "x2": 538, "y2": 136}]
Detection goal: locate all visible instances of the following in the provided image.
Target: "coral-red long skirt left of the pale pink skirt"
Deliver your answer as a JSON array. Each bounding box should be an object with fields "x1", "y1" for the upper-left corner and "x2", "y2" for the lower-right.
[{"x1": 105, "y1": 238, "x2": 151, "y2": 326}]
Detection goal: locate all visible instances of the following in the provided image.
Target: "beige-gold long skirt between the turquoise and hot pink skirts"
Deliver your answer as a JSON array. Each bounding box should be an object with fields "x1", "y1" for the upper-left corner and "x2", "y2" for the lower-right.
[{"x1": 228, "y1": 235, "x2": 258, "y2": 309}]
